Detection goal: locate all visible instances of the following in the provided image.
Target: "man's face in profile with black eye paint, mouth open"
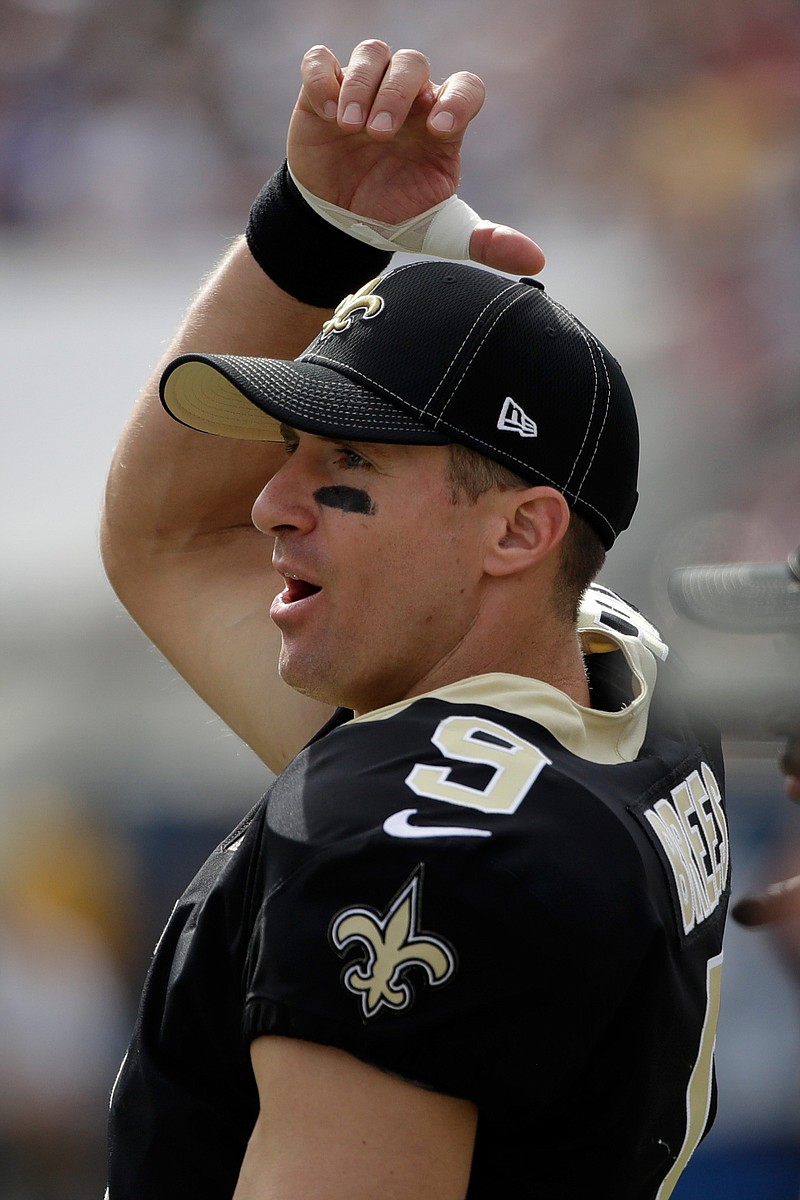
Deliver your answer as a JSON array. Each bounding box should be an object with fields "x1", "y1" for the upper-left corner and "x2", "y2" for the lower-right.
[{"x1": 253, "y1": 428, "x2": 498, "y2": 712}]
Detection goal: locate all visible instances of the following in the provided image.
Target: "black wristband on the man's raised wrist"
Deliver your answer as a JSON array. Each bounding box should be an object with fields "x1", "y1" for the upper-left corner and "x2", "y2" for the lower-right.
[{"x1": 245, "y1": 162, "x2": 392, "y2": 308}]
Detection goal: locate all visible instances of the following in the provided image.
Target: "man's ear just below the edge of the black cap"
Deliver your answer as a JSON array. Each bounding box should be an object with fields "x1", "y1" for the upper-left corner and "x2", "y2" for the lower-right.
[{"x1": 483, "y1": 487, "x2": 570, "y2": 576}]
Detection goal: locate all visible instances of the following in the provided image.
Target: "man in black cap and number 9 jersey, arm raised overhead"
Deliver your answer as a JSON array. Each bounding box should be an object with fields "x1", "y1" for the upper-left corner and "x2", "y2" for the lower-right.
[{"x1": 103, "y1": 42, "x2": 728, "y2": 1200}]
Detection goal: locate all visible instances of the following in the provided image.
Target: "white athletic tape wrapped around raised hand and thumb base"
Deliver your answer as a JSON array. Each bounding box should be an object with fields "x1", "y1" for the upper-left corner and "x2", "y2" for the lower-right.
[{"x1": 289, "y1": 167, "x2": 481, "y2": 258}]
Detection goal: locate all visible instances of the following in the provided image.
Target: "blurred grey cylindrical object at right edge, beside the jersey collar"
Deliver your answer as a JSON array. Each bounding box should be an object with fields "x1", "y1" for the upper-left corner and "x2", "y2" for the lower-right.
[{"x1": 667, "y1": 546, "x2": 800, "y2": 634}]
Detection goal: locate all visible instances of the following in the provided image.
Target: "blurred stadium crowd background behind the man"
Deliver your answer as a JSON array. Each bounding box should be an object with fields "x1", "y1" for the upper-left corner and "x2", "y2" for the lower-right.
[{"x1": 0, "y1": 0, "x2": 800, "y2": 1200}]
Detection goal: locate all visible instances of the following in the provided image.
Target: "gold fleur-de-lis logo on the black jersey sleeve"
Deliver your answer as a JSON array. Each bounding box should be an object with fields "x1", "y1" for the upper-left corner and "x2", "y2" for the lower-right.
[{"x1": 331, "y1": 866, "x2": 456, "y2": 1018}]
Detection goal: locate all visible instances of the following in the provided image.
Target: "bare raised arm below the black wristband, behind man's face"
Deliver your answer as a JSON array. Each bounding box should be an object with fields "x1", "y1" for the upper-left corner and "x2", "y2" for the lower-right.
[{"x1": 101, "y1": 239, "x2": 326, "y2": 770}]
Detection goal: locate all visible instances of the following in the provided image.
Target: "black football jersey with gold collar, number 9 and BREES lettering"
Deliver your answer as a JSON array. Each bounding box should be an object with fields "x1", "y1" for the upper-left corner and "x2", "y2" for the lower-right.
[{"x1": 109, "y1": 588, "x2": 729, "y2": 1200}]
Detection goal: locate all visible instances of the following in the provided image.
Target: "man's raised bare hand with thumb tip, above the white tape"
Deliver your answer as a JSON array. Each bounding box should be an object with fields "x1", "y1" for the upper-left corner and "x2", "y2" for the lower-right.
[{"x1": 288, "y1": 41, "x2": 545, "y2": 275}]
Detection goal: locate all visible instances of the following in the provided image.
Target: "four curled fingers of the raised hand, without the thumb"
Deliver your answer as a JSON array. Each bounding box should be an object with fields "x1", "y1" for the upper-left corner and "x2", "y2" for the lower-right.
[{"x1": 301, "y1": 40, "x2": 486, "y2": 140}]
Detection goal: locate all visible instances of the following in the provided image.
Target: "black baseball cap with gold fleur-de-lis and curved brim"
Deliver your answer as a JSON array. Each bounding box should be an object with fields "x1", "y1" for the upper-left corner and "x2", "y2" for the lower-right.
[{"x1": 161, "y1": 260, "x2": 639, "y2": 548}]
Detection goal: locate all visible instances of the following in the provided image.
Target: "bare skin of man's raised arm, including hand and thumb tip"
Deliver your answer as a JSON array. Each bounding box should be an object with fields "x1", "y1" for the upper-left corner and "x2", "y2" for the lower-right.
[{"x1": 102, "y1": 42, "x2": 543, "y2": 770}]
